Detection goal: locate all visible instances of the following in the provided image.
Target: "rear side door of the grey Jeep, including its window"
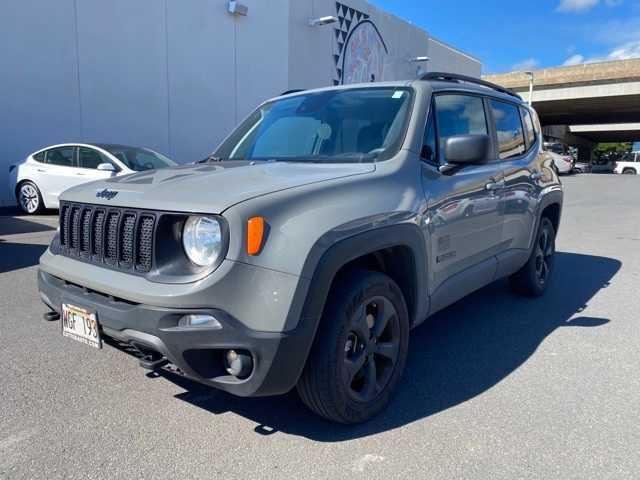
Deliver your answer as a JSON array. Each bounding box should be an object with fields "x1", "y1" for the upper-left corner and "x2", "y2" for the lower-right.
[{"x1": 489, "y1": 99, "x2": 540, "y2": 276}]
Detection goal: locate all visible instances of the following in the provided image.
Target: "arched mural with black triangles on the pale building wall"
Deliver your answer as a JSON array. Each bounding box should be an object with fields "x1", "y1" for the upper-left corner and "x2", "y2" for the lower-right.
[{"x1": 333, "y1": 2, "x2": 389, "y2": 85}]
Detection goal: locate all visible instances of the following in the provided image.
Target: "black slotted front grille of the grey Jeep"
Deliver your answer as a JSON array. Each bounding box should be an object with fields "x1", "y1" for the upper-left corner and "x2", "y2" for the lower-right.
[{"x1": 60, "y1": 203, "x2": 157, "y2": 273}]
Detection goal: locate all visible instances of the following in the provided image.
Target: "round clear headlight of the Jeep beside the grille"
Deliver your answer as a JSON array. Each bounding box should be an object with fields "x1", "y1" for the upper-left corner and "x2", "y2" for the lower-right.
[{"x1": 182, "y1": 217, "x2": 222, "y2": 267}]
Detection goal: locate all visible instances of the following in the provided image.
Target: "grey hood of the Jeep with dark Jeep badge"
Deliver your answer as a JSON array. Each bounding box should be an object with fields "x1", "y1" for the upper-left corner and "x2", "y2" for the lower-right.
[{"x1": 61, "y1": 161, "x2": 376, "y2": 213}]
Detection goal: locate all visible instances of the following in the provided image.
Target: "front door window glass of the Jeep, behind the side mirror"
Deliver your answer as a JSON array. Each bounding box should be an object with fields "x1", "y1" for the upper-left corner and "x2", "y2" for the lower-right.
[{"x1": 435, "y1": 95, "x2": 488, "y2": 161}]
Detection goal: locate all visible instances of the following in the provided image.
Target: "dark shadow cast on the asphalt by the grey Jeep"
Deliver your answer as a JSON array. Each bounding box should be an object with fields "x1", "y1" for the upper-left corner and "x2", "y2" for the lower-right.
[{"x1": 139, "y1": 253, "x2": 622, "y2": 442}]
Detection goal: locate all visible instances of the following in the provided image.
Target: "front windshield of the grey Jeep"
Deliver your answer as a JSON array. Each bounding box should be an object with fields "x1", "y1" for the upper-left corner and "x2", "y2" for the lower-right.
[{"x1": 213, "y1": 87, "x2": 412, "y2": 163}]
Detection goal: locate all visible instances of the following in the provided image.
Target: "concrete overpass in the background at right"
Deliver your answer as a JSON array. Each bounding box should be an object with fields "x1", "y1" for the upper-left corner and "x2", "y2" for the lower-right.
[{"x1": 484, "y1": 59, "x2": 640, "y2": 143}]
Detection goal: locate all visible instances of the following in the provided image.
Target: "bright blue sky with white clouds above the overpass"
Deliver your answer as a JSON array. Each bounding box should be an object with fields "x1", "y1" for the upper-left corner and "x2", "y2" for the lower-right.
[{"x1": 369, "y1": 0, "x2": 640, "y2": 73}]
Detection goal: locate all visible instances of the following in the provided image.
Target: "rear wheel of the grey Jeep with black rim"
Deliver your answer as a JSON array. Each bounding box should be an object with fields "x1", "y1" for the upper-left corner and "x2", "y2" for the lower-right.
[{"x1": 509, "y1": 217, "x2": 556, "y2": 297}]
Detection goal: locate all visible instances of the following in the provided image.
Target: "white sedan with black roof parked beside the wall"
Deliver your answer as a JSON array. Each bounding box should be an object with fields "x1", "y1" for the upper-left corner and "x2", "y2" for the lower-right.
[{"x1": 9, "y1": 143, "x2": 176, "y2": 214}]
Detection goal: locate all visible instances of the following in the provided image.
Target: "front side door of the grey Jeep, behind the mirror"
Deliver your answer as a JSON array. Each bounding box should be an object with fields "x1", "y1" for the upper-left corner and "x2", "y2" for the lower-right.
[{"x1": 421, "y1": 93, "x2": 504, "y2": 312}]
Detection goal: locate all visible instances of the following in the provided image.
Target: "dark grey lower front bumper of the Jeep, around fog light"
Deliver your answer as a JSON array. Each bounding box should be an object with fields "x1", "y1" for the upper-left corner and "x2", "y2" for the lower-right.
[{"x1": 38, "y1": 270, "x2": 317, "y2": 397}]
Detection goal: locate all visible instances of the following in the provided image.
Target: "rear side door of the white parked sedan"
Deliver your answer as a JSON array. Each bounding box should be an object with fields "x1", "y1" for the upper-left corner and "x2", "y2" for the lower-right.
[{"x1": 36, "y1": 145, "x2": 77, "y2": 208}]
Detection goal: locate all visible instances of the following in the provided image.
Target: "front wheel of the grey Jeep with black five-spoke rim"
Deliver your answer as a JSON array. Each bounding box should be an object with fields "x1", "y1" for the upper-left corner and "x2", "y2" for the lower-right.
[{"x1": 297, "y1": 270, "x2": 409, "y2": 424}]
